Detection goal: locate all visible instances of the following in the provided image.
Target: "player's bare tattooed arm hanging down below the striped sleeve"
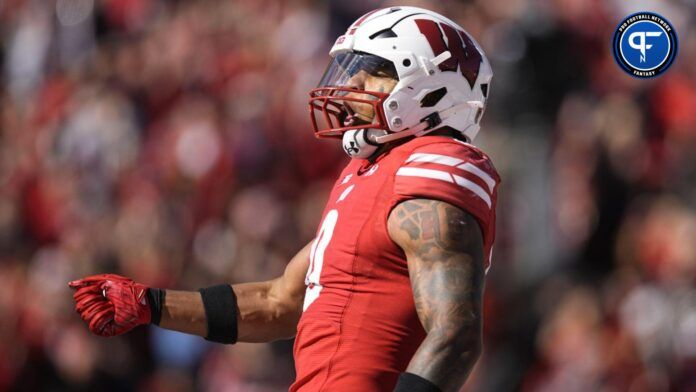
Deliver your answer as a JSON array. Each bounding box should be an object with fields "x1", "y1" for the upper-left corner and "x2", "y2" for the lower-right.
[{"x1": 388, "y1": 199, "x2": 484, "y2": 391}]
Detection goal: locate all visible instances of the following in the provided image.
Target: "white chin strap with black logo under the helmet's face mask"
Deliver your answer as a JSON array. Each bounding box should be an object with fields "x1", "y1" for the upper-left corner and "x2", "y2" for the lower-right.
[{"x1": 343, "y1": 101, "x2": 483, "y2": 159}]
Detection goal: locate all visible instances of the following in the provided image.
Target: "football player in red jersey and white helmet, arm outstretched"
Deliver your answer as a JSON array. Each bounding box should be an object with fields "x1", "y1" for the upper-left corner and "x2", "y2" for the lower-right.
[{"x1": 70, "y1": 7, "x2": 500, "y2": 392}]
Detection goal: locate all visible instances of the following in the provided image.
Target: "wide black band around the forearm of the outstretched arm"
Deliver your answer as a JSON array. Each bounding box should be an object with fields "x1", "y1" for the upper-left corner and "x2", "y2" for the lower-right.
[{"x1": 198, "y1": 284, "x2": 237, "y2": 344}]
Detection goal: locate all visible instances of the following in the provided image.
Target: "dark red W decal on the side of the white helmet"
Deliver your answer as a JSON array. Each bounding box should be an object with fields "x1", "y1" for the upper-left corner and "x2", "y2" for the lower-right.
[{"x1": 415, "y1": 19, "x2": 481, "y2": 88}]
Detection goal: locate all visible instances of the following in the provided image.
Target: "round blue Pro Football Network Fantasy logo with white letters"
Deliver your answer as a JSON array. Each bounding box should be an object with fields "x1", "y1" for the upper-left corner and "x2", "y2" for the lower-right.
[{"x1": 612, "y1": 12, "x2": 679, "y2": 78}]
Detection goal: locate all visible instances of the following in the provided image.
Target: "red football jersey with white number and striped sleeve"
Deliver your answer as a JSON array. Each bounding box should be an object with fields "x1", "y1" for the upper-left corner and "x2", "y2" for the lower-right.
[{"x1": 290, "y1": 136, "x2": 500, "y2": 392}]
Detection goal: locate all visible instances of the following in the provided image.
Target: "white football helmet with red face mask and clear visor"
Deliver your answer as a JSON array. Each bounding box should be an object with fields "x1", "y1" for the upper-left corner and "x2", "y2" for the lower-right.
[{"x1": 309, "y1": 7, "x2": 493, "y2": 157}]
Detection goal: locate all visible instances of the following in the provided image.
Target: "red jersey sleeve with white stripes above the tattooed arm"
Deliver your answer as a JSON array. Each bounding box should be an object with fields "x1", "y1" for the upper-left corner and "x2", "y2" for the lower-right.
[{"x1": 392, "y1": 142, "x2": 500, "y2": 270}]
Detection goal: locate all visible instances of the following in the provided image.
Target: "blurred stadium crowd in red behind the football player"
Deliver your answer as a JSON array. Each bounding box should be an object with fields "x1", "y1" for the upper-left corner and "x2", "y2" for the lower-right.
[{"x1": 0, "y1": 0, "x2": 696, "y2": 392}]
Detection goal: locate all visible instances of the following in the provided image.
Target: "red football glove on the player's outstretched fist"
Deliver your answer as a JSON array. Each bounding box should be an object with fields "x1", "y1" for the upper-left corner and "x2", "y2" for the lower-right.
[{"x1": 68, "y1": 274, "x2": 151, "y2": 336}]
